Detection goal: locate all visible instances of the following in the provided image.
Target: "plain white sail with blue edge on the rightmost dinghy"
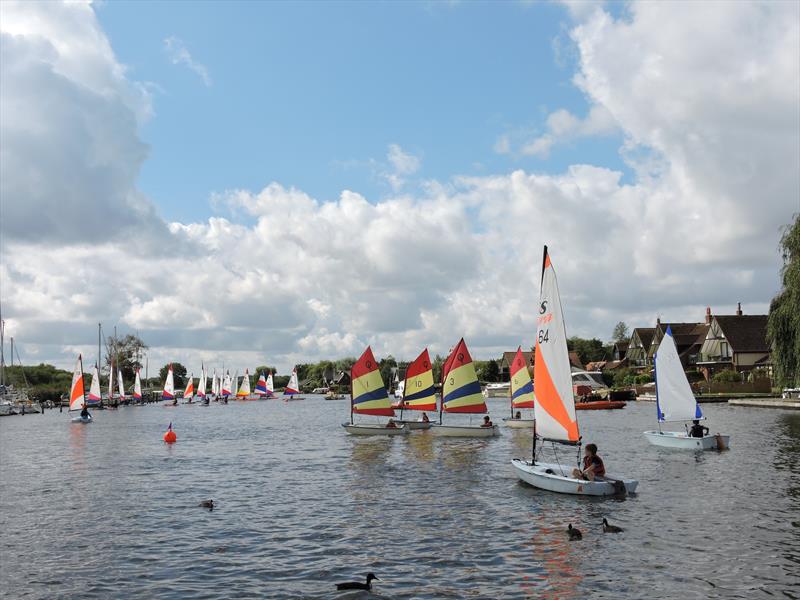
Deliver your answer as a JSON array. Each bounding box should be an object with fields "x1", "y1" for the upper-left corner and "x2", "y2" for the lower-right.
[{"x1": 654, "y1": 327, "x2": 703, "y2": 422}]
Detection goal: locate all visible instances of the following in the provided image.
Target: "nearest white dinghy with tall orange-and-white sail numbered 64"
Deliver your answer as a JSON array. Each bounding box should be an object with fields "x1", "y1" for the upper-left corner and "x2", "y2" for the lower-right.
[{"x1": 511, "y1": 246, "x2": 639, "y2": 496}]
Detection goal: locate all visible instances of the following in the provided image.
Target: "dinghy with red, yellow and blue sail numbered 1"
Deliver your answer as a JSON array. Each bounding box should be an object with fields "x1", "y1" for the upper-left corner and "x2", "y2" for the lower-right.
[{"x1": 342, "y1": 346, "x2": 409, "y2": 435}]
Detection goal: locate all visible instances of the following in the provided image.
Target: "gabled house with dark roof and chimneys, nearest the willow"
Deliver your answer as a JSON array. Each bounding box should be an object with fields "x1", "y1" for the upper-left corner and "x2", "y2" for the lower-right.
[{"x1": 698, "y1": 303, "x2": 772, "y2": 379}]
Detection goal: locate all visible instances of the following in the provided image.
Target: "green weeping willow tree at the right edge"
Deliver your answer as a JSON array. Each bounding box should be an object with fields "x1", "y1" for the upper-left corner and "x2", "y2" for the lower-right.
[{"x1": 767, "y1": 214, "x2": 800, "y2": 386}]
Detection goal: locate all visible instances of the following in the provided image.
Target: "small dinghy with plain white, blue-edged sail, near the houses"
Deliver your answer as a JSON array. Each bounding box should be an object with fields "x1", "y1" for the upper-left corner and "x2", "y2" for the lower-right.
[{"x1": 644, "y1": 327, "x2": 730, "y2": 450}]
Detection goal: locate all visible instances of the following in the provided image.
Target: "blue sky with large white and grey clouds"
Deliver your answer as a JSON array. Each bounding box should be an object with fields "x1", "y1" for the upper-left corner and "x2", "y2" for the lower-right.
[{"x1": 0, "y1": 1, "x2": 800, "y2": 372}]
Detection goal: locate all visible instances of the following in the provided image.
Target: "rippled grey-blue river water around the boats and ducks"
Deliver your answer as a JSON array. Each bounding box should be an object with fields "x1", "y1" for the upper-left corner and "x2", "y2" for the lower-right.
[{"x1": 0, "y1": 397, "x2": 800, "y2": 599}]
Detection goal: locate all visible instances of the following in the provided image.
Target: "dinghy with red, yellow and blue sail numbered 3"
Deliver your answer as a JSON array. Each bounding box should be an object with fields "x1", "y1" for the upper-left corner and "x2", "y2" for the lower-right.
[{"x1": 431, "y1": 338, "x2": 498, "y2": 437}]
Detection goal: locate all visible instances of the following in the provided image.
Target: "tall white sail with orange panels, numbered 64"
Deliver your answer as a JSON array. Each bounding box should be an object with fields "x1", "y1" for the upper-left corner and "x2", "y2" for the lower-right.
[{"x1": 533, "y1": 246, "x2": 580, "y2": 442}]
